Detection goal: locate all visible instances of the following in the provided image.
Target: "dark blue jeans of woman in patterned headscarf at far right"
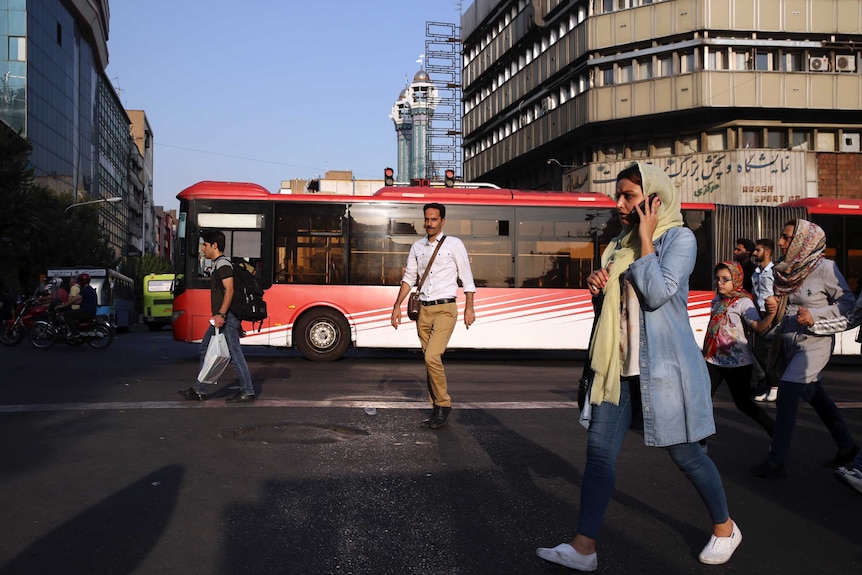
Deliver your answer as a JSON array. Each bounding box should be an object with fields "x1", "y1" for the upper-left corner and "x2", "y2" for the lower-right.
[{"x1": 769, "y1": 380, "x2": 853, "y2": 465}]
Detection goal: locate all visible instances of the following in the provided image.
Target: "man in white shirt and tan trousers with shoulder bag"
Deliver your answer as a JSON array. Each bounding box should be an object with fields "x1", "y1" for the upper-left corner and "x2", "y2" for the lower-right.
[{"x1": 391, "y1": 203, "x2": 476, "y2": 429}]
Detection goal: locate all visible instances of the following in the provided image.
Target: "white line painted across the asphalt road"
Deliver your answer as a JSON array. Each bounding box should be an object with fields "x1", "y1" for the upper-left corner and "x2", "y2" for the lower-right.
[{"x1": 0, "y1": 398, "x2": 862, "y2": 413}]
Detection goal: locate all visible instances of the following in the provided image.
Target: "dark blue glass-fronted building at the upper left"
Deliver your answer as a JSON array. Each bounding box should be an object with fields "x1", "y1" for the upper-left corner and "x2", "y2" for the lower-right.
[{"x1": 0, "y1": 0, "x2": 130, "y2": 255}]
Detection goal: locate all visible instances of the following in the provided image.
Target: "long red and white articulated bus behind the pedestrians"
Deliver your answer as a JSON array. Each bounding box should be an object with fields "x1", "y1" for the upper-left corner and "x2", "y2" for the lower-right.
[{"x1": 173, "y1": 182, "x2": 862, "y2": 361}]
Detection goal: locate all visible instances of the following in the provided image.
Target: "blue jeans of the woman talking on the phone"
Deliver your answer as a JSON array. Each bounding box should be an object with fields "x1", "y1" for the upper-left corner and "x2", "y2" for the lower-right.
[{"x1": 578, "y1": 378, "x2": 729, "y2": 539}]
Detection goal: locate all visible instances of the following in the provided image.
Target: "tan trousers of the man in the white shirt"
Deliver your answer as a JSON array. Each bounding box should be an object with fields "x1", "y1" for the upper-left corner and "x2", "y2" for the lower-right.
[{"x1": 416, "y1": 303, "x2": 458, "y2": 407}]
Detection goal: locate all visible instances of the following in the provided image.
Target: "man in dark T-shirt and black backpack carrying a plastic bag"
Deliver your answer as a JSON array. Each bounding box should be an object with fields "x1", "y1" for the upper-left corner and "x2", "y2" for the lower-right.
[{"x1": 179, "y1": 230, "x2": 257, "y2": 403}]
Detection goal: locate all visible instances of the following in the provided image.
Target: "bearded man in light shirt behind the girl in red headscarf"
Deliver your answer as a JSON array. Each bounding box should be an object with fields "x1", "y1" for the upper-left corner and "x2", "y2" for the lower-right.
[{"x1": 751, "y1": 238, "x2": 778, "y2": 401}]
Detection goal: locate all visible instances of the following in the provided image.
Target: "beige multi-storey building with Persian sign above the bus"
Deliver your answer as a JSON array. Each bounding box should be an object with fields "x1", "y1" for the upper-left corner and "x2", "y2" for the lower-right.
[{"x1": 461, "y1": 0, "x2": 862, "y2": 205}]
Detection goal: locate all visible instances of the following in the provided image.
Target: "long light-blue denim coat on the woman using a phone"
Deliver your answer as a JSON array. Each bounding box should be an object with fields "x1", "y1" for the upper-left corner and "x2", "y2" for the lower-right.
[{"x1": 584, "y1": 227, "x2": 715, "y2": 447}]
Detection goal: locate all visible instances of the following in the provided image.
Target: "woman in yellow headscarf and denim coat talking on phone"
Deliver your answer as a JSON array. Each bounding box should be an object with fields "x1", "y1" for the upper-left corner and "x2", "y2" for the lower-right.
[{"x1": 536, "y1": 162, "x2": 742, "y2": 571}]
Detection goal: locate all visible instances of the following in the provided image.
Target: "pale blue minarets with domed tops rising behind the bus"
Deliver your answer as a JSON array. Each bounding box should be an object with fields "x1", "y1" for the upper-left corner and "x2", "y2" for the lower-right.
[{"x1": 389, "y1": 66, "x2": 440, "y2": 182}]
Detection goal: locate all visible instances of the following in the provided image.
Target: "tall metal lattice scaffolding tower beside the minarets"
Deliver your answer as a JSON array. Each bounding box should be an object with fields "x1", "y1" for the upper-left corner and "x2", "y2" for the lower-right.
[{"x1": 425, "y1": 22, "x2": 464, "y2": 180}]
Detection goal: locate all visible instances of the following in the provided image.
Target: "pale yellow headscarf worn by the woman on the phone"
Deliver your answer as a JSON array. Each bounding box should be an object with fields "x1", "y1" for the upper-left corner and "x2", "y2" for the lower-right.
[{"x1": 590, "y1": 162, "x2": 683, "y2": 405}]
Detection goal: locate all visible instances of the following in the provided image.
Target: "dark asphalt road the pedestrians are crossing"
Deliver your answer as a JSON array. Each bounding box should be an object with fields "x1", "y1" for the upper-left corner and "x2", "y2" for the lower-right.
[{"x1": 0, "y1": 331, "x2": 862, "y2": 575}]
